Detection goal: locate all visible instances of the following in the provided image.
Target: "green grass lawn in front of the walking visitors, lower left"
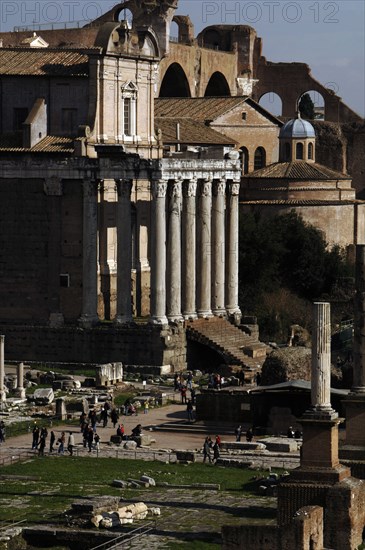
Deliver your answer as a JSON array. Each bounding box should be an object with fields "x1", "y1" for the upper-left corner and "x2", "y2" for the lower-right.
[{"x1": 0, "y1": 456, "x2": 267, "y2": 523}]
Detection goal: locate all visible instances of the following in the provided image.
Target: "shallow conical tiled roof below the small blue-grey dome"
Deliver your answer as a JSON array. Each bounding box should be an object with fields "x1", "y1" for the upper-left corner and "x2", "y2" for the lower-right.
[{"x1": 244, "y1": 160, "x2": 351, "y2": 180}]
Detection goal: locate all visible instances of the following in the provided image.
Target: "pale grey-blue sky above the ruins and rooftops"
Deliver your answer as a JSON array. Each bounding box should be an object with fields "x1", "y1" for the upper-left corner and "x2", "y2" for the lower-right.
[{"x1": 0, "y1": 0, "x2": 365, "y2": 116}]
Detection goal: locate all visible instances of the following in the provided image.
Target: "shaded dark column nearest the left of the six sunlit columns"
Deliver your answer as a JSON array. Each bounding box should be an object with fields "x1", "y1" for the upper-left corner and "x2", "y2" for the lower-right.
[{"x1": 114, "y1": 180, "x2": 132, "y2": 325}]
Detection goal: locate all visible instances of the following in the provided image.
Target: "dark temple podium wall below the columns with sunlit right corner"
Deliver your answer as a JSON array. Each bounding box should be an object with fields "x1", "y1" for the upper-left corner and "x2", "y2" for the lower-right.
[{"x1": 0, "y1": 325, "x2": 186, "y2": 370}]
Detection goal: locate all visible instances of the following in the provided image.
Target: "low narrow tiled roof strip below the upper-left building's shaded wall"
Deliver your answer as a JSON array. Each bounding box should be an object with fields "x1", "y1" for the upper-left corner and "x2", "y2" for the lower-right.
[{"x1": 0, "y1": 133, "x2": 74, "y2": 153}]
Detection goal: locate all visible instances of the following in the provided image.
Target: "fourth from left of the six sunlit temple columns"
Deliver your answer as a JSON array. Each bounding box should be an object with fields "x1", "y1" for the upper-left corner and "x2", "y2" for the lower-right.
[{"x1": 197, "y1": 179, "x2": 212, "y2": 317}]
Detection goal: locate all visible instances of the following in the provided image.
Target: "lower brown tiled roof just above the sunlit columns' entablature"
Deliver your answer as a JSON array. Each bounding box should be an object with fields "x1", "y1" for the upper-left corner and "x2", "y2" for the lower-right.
[{"x1": 155, "y1": 117, "x2": 236, "y2": 145}]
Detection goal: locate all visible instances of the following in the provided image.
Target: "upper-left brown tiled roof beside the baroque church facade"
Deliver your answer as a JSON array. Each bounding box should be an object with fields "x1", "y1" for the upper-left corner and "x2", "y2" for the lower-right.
[{"x1": 0, "y1": 48, "x2": 89, "y2": 76}]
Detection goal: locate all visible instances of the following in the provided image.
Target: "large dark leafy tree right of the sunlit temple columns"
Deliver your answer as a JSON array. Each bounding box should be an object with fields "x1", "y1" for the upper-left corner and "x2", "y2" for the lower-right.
[{"x1": 239, "y1": 211, "x2": 353, "y2": 341}]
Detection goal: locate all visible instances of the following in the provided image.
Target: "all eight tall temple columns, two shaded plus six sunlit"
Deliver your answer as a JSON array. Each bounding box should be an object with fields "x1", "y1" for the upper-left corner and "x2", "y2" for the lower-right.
[{"x1": 80, "y1": 178, "x2": 240, "y2": 326}]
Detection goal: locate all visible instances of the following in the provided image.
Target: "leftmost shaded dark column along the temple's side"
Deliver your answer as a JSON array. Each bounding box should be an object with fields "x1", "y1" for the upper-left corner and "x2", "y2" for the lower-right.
[{"x1": 79, "y1": 179, "x2": 99, "y2": 328}]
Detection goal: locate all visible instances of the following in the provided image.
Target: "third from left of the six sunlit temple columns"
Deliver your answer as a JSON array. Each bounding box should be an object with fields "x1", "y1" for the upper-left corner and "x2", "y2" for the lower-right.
[{"x1": 182, "y1": 178, "x2": 197, "y2": 319}]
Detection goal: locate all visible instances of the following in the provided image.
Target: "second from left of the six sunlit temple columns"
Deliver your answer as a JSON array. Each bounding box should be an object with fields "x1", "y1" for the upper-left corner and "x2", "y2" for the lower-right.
[{"x1": 166, "y1": 179, "x2": 183, "y2": 321}]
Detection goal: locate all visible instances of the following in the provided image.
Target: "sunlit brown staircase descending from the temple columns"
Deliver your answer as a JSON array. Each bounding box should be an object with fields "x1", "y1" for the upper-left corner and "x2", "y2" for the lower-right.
[{"x1": 186, "y1": 317, "x2": 266, "y2": 382}]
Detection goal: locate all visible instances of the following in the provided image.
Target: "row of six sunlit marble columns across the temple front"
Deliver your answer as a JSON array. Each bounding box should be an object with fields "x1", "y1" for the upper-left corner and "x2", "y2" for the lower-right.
[{"x1": 151, "y1": 178, "x2": 239, "y2": 324}]
